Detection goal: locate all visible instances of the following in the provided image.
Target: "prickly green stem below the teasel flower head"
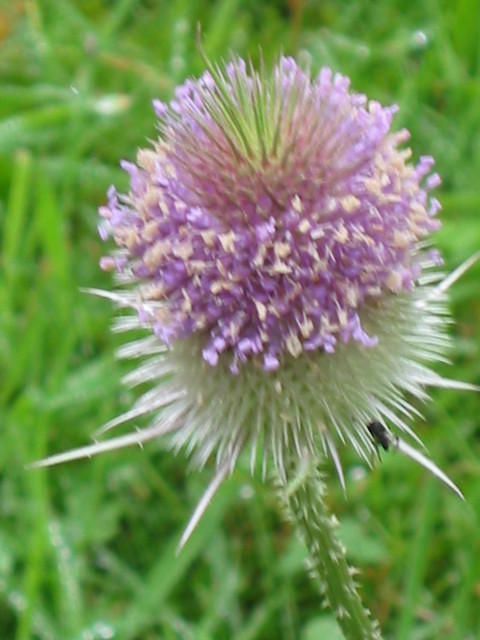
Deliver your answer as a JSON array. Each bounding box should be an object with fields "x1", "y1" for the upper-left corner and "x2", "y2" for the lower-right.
[{"x1": 280, "y1": 464, "x2": 381, "y2": 640}]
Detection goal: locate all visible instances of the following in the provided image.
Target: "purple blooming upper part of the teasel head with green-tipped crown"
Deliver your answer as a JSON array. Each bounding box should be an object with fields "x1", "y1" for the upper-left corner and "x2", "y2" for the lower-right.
[{"x1": 101, "y1": 58, "x2": 438, "y2": 372}]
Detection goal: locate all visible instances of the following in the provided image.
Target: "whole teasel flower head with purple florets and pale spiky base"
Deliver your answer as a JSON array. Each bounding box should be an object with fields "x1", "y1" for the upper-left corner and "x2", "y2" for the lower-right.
[{"x1": 35, "y1": 57, "x2": 478, "y2": 535}]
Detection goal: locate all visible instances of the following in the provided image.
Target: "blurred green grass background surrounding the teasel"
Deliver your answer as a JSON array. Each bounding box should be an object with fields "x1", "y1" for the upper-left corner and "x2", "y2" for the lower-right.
[{"x1": 0, "y1": 0, "x2": 480, "y2": 640}]
